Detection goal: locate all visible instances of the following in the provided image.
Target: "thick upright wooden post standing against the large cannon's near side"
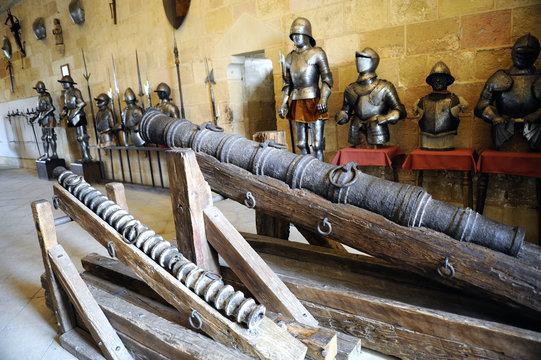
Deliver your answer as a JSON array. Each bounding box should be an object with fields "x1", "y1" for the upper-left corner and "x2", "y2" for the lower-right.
[{"x1": 166, "y1": 149, "x2": 220, "y2": 274}]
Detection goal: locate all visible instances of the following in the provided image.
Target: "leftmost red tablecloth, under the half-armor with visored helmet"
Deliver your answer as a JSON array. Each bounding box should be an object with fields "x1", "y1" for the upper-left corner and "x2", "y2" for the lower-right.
[{"x1": 332, "y1": 146, "x2": 404, "y2": 167}]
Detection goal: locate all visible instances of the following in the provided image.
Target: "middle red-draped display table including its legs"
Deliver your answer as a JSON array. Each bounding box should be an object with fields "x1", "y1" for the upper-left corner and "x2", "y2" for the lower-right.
[{"x1": 402, "y1": 148, "x2": 476, "y2": 208}]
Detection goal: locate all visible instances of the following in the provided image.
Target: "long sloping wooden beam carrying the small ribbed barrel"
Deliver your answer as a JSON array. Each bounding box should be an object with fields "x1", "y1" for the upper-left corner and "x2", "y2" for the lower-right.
[{"x1": 54, "y1": 185, "x2": 306, "y2": 359}]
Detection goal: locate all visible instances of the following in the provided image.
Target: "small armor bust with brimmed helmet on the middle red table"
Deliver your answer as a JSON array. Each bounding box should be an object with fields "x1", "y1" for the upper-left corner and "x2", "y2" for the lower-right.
[{"x1": 413, "y1": 61, "x2": 468, "y2": 150}]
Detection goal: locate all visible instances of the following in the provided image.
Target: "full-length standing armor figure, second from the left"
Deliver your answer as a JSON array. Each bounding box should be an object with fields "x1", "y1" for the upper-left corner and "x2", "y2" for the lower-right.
[{"x1": 58, "y1": 75, "x2": 92, "y2": 163}]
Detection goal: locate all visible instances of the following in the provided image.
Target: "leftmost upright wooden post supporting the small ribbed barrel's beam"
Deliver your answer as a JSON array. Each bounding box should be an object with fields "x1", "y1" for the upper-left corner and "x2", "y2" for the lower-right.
[{"x1": 32, "y1": 200, "x2": 75, "y2": 334}]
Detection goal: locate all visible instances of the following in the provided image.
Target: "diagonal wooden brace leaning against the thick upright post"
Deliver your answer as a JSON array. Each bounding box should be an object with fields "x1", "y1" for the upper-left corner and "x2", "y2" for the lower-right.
[{"x1": 203, "y1": 206, "x2": 317, "y2": 326}]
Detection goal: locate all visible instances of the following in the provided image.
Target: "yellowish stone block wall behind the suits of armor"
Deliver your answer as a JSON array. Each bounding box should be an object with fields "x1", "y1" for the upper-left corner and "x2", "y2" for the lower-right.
[{"x1": 0, "y1": 0, "x2": 541, "y2": 242}]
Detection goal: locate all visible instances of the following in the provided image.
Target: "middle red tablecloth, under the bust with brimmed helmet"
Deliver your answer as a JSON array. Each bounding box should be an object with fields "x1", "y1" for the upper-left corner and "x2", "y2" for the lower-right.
[{"x1": 402, "y1": 149, "x2": 476, "y2": 171}]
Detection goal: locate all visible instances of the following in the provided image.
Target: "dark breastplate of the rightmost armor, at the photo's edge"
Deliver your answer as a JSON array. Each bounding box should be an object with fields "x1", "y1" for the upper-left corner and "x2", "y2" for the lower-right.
[{"x1": 496, "y1": 73, "x2": 541, "y2": 118}]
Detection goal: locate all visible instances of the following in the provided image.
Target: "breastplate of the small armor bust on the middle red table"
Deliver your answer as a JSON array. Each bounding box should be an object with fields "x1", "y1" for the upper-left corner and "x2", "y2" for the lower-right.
[{"x1": 419, "y1": 93, "x2": 460, "y2": 136}]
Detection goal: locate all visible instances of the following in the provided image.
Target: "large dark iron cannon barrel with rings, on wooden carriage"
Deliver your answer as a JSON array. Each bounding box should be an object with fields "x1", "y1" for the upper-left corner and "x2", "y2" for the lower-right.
[{"x1": 140, "y1": 109, "x2": 525, "y2": 256}]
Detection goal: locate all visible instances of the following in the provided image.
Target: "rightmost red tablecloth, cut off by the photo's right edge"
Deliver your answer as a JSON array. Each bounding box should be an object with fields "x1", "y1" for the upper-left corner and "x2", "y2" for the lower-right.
[{"x1": 477, "y1": 150, "x2": 541, "y2": 177}]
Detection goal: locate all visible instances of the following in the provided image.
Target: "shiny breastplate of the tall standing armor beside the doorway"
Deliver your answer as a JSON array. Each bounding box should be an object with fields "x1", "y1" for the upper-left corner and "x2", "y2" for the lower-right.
[{"x1": 290, "y1": 48, "x2": 320, "y2": 100}]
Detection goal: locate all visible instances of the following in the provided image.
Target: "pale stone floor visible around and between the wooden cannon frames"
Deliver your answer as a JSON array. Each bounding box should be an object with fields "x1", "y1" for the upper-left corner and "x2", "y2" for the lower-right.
[{"x1": 0, "y1": 169, "x2": 388, "y2": 360}]
